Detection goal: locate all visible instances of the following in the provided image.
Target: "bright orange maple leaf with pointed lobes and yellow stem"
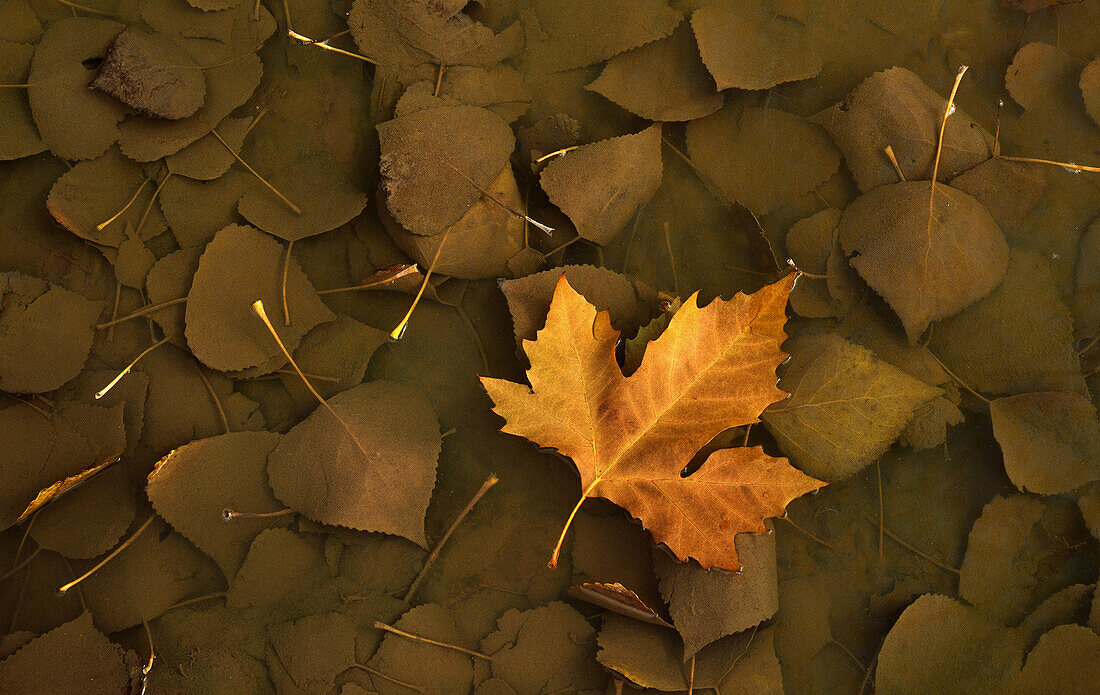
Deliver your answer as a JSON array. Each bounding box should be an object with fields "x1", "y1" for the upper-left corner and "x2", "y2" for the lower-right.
[{"x1": 481, "y1": 275, "x2": 824, "y2": 571}]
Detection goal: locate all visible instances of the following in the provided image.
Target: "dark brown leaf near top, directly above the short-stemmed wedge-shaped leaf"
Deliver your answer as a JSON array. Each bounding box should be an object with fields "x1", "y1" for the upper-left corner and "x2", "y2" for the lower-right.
[{"x1": 585, "y1": 22, "x2": 725, "y2": 121}]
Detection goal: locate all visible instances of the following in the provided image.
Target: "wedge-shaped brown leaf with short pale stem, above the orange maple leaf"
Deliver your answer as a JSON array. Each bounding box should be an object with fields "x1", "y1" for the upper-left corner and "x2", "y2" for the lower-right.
[{"x1": 539, "y1": 124, "x2": 663, "y2": 245}]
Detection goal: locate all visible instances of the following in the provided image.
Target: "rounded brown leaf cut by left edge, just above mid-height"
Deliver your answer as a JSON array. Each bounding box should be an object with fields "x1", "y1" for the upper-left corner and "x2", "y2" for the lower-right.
[{"x1": 0, "y1": 273, "x2": 102, "y2": 394}]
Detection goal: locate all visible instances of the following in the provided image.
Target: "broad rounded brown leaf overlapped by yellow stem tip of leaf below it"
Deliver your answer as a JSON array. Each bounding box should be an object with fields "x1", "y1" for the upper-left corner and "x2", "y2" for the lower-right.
[{"x1": 186, "y1": 224, "x2": 333, "y2": 372}]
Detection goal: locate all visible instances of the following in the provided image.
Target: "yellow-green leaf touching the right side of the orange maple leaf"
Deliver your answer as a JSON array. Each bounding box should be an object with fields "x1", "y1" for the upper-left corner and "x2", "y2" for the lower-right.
[{"x1": 761, "y1": 333, "x2": 939, "y2": 481}]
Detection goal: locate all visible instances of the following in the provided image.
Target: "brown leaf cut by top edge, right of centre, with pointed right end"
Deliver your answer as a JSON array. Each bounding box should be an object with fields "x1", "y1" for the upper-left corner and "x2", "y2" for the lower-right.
[{"x1": 691, "y1": 2, "x2": 822, "y2": 89}]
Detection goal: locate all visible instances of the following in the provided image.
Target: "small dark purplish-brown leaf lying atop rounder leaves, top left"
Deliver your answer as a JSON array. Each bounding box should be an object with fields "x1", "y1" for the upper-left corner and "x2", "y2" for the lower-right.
[{"x1": 90, "y1": 27, "x2": 206, "y2": 120}]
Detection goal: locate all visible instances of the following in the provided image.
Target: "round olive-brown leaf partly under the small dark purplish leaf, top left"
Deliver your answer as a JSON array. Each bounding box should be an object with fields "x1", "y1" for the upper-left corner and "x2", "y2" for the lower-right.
[{"x1": 26, "y1": 16, "x2": 125, "y2": 159}]
